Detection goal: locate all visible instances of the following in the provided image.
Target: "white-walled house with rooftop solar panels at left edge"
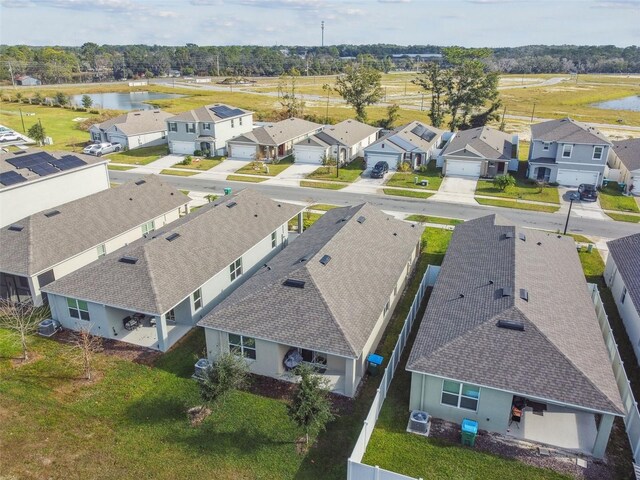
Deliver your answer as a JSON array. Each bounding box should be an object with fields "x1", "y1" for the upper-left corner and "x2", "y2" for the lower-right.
[{"x1": 0, "y1": 149, "x2": 109, "y2": 227}]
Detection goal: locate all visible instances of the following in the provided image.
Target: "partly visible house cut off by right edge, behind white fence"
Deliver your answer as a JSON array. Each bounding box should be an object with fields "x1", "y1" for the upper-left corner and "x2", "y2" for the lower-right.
[{"x1": 604, "y1": 233, "x2": 640, "y2": 365}]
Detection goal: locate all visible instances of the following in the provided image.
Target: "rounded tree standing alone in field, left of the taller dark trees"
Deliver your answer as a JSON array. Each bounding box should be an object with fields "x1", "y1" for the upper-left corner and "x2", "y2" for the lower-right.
[{"x1": 335, "y1": 65, "x2": 384, "y2": 122}]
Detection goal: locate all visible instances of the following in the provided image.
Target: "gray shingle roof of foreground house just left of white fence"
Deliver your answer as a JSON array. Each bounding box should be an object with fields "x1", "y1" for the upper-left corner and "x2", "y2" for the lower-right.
[{"x1": 198, "y1": 204, "x2": 421, "y2": 358}]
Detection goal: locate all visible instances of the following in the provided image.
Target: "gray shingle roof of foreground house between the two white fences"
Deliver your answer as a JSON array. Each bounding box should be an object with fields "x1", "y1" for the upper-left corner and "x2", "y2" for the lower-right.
[{"x1": 407, "y1": 215, "x2": 624, "y2": 415}]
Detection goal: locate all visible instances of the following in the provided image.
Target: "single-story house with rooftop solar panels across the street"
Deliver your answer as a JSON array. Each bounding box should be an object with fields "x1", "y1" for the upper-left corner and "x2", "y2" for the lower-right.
[{"x1": 364, "y1": 121, "x2": 446, "y2": 170}]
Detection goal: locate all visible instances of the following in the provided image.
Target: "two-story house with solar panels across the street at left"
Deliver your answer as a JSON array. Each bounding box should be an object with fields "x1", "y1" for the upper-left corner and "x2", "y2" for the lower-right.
[{"x1": 167, "y1": 104, "x2": 253, "y2": 155}]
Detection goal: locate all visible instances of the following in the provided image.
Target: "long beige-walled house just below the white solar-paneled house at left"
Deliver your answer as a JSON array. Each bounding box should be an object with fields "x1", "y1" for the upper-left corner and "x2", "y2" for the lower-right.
[{"x1": 0, "y1": 175, "x2": 189, "y2": 305}]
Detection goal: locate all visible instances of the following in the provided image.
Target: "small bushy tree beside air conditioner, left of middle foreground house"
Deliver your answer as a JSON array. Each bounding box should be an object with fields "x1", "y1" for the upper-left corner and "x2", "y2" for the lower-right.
[{"x1": 197, "y1": 353, "x2": 249, "y2": 408}]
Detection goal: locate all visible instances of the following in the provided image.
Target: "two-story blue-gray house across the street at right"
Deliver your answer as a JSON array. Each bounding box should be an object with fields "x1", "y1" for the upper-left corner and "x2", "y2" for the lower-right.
[{"x1": 527, "y1": 117, "x2": 611, "y2": 187}]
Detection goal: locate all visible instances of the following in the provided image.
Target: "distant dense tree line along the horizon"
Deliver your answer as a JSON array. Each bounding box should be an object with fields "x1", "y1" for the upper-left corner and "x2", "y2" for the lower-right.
[{"x1": 0, "y1": 43, "x2": 640, "y2": 84}]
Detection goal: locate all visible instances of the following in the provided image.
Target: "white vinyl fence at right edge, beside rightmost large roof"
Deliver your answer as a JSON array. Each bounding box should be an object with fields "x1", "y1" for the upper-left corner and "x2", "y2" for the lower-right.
[{"x1": 589, "y1": 283, "x2": 640, "y2": 464}]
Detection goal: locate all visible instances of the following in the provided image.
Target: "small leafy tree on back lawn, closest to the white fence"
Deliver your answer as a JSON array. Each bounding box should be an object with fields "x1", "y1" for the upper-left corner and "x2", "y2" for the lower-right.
[{"x1": 288, "y1": 364, "x2": 335, "y2": 445}]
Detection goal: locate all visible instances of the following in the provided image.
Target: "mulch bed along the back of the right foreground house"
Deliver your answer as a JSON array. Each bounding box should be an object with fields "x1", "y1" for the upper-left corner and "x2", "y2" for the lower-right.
[{"x1": 430, "y1": 418, "x2": 616, "y2": 480}]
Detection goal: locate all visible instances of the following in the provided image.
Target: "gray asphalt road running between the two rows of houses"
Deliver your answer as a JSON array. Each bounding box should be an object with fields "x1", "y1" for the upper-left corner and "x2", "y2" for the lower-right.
[{"x1": 109, "y1": 170, "x2": 640, "y2": 239}]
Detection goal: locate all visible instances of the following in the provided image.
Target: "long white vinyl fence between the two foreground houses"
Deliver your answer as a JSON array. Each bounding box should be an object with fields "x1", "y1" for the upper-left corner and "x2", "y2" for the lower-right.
[{"x1": 347, "y1": 265, "x2": 440, "y2": 480}]
